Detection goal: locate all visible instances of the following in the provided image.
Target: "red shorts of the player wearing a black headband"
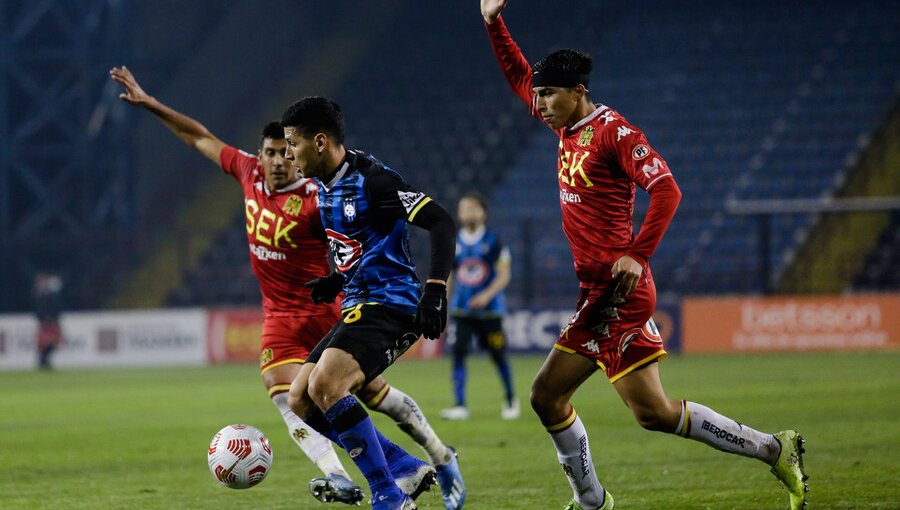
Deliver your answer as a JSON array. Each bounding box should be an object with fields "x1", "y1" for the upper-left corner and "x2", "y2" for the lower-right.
[{"x1": 553, "y1": 278, "x2": 667, "y2": 382}]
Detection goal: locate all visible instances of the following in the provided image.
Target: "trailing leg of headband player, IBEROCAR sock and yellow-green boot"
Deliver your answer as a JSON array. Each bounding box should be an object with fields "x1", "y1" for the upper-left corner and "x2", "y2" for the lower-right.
[{"x1": 613, "y1": 362, "x2": 807, "y2": 509}]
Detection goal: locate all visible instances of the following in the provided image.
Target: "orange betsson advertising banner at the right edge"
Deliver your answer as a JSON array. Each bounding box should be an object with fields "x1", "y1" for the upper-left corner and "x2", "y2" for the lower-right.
[{"x1": 681, "y1": 294, "x2": 900, "y2": 353}]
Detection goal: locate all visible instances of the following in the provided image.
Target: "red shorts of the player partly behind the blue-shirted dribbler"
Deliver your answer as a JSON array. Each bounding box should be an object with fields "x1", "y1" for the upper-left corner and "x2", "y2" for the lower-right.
[{"x1": 259, "y1": 314, "x2": 340, "y2": 373}]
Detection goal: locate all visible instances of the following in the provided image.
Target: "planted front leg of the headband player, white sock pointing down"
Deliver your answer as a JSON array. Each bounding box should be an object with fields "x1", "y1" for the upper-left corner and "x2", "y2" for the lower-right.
[{"x1": 531, "y1": 348, "x2": 612, "y2": 510}]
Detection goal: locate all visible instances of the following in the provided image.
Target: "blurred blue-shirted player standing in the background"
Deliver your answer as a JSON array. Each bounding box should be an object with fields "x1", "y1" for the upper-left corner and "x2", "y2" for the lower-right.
[{"x1": 441, "y1": 192, "x2": 519, "y2": 420}]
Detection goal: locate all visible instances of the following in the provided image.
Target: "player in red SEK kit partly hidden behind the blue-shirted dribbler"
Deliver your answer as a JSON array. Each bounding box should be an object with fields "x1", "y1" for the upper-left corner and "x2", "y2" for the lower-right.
[{"x1": 110, "y1": 67, "x2": 464, "y2": 504}]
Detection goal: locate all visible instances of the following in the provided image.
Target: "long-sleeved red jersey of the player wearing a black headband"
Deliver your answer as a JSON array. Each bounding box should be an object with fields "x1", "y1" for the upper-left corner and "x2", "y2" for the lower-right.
[{"x1": 487, "y1": 18, "x2": 680, "y2": 287}]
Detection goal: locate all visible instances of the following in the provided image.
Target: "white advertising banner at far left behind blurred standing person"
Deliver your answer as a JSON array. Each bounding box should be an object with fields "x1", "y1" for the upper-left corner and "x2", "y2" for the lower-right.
[{"x1": 0, "y1": 309, "x2": 206, "y2": 369}]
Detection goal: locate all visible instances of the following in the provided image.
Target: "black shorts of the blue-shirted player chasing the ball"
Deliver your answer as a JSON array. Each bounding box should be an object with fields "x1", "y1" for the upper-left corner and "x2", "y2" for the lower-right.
[{"x1": 306, "y1": 304, "x2": 421, "y2": 384}]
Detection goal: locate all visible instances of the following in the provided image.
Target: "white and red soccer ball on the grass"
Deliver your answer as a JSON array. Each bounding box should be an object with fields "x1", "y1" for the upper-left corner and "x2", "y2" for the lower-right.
[{"x1": 206, "y1": 424, "x2": 272, "y2": 489}]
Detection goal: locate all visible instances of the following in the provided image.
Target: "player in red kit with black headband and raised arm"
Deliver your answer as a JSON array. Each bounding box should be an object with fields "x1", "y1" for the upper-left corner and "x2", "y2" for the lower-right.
[{"x1": 481, "y1": 0, "x2": 806, "y2": 510}]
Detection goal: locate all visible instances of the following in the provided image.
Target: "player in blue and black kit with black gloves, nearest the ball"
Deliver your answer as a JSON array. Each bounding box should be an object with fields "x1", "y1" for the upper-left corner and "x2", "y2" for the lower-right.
[{"x1": 281, "y1": 97, "x2": 465, "y2": 510}]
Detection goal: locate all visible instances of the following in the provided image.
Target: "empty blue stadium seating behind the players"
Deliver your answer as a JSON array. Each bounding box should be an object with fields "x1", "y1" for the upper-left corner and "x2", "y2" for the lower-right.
[{"x1": 170, "y1": 0, "x2": 900, "y2": 307}]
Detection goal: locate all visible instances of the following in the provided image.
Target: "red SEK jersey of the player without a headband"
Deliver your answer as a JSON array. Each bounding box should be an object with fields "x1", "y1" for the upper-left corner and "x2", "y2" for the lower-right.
[{"x1": 219, "y1": 146, "x2": 339, "y2": 316}]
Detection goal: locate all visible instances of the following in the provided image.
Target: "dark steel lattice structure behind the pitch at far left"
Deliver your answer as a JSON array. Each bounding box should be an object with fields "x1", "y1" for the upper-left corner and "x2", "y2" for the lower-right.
[{"x1": 0, "y1": 0, "x2": 133, "y2": 311}]
